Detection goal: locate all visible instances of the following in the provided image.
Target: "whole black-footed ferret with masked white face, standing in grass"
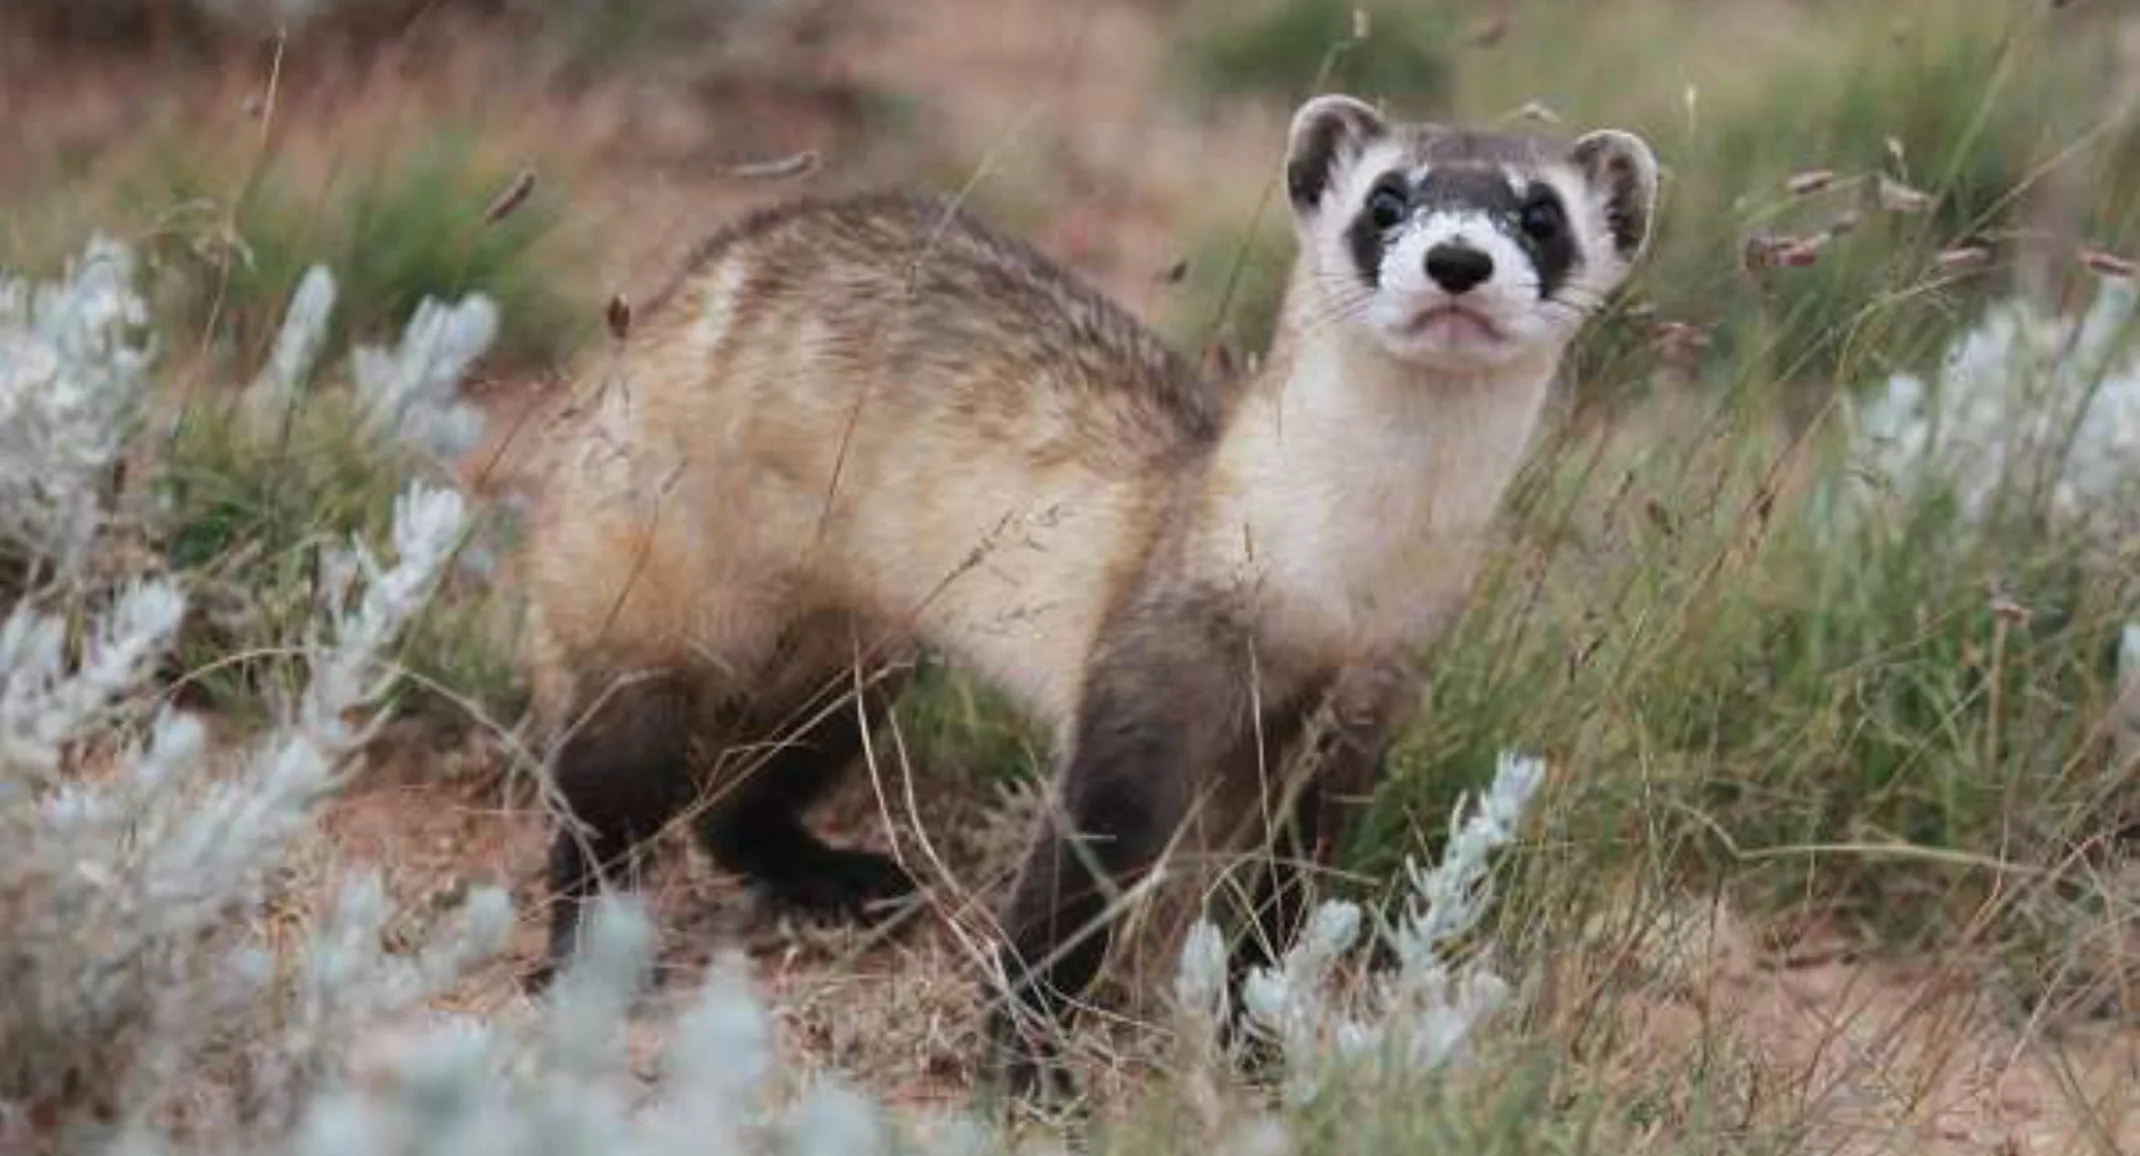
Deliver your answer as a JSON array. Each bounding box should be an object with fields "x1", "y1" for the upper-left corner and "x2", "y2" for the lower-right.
[{"x1": 522, "y1": 96, "x2": 1656, "y2": 1087}]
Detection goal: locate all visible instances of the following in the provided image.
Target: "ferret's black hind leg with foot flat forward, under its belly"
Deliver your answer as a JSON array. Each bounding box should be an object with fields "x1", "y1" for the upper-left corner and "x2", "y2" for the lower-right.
[{"x1": 698, "y1": 685, "x2": 914, "y2": 918}]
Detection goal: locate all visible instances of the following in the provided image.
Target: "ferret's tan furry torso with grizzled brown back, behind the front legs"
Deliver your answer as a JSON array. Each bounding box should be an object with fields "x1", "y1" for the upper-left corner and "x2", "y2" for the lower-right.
[{"x1": 529, "y1": 197, "x2": 1216, "y2": 724}]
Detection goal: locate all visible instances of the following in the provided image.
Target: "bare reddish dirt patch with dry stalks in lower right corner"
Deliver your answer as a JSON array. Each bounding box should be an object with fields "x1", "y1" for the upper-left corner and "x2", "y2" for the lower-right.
[{"x1": 1624, "y1": 906, "x2": 2140, "y2": 1156}]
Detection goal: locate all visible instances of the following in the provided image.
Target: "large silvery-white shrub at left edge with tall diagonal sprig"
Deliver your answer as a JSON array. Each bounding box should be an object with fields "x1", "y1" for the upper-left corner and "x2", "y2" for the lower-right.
[{"x1": 0, "y1": 473, "x2": 481, "y2": 1139}]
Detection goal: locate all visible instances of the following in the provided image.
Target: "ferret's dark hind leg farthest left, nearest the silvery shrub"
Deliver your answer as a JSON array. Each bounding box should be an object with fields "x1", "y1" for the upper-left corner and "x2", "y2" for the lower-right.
[{"x1": 526, "y1": 674, "x2": 693, "y2": 989}]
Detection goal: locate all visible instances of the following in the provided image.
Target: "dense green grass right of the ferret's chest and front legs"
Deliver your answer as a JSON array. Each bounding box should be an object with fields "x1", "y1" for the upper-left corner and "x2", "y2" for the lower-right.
[{"x1": 1352, "y1": 325, "x2": 2140, "y2": 993}]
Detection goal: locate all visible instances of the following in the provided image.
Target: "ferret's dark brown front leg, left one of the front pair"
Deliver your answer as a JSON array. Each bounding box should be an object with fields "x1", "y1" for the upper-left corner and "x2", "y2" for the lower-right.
[{"x1": 989, "y1": 604, "x2": 1248, "y2": 1096}]
